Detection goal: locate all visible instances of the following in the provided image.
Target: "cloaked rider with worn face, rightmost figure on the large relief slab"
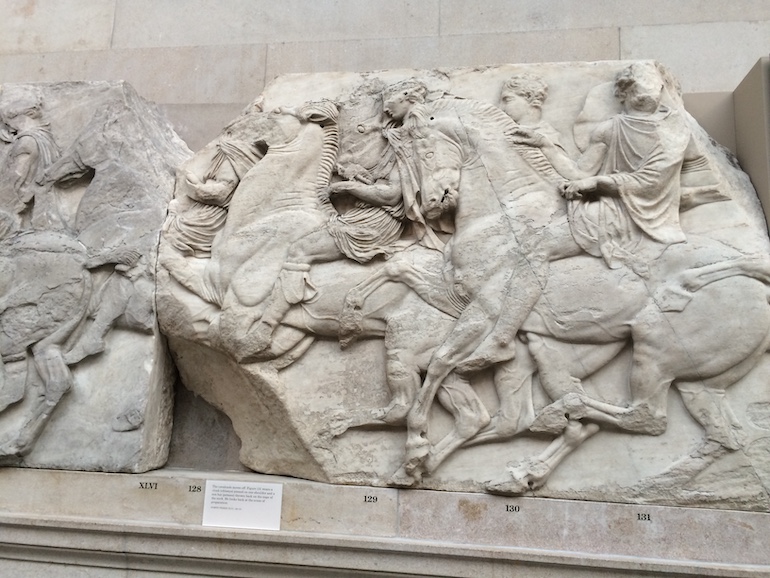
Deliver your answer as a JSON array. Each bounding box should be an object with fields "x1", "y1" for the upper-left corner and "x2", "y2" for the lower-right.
[{"x1": 470, "y1": 63, "x2": 691, "y2": 365}]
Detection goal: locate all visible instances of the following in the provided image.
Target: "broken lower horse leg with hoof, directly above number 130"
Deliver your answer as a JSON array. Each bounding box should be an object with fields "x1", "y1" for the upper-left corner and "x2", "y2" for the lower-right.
[{"x1": 485, "y1": 420, "x2": 599, "y2": 496}]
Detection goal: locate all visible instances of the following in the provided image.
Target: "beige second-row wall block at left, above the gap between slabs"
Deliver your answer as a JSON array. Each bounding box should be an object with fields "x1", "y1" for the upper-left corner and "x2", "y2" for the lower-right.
[{"x1": 0, "y1": 44, "x2": 266, "y2": 103}]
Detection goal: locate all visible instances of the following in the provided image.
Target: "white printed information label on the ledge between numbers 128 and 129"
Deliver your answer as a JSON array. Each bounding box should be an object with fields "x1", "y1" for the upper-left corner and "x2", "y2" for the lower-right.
[{"x1": 203, "y1": 480, "x2": 283, "y2": 530}]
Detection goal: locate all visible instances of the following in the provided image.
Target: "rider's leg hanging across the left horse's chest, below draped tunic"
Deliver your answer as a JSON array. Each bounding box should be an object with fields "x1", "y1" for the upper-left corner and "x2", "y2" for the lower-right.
[{"x1": 252, "y1": 229, "x2": 342, "y2": 353}]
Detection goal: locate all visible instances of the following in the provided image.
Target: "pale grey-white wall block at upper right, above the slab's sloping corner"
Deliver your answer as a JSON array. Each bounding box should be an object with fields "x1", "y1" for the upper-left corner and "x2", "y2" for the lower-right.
[{"x1": 620, "y1": 20, "x2": 770, "y2": 92}]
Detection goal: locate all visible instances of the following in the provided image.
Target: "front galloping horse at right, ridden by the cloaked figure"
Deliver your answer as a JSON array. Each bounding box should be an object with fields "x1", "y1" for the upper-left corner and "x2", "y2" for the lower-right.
[{"x1": 392, "y1": 95, "x2": 770, "y2": 493}]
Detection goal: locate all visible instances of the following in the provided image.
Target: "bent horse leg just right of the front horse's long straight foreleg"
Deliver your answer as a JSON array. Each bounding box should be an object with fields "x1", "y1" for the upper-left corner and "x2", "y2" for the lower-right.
[{"x1": 424, "y1": 374, "x2": 490, "y2": 473}]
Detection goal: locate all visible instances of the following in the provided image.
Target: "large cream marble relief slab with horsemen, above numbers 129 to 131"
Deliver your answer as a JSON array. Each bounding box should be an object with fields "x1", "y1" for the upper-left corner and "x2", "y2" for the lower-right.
[{"x1": 158, "y1": 62, "x2": 770, "y2": 510}]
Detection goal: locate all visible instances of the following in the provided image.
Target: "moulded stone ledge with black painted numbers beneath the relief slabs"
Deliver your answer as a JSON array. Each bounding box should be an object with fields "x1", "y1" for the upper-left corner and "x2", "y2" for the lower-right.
[{"x1": 0, "y1": 469, "x2": 770, "y2": 578}]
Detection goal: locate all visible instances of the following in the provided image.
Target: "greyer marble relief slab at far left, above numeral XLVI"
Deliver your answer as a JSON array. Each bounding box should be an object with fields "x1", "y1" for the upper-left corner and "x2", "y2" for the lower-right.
[{"x1": 0, "y1": 83, "x2": 191, "y2": 472}]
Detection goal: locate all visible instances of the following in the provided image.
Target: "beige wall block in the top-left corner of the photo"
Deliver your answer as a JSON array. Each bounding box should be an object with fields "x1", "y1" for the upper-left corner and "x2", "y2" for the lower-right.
[{"x1": 0, "y1": 0, "x2": 116, "y2": 54}]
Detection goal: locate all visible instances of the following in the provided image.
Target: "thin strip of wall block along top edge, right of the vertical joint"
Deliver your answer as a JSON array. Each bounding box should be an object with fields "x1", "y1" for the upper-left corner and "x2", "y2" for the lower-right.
[{"x1": 441, "y1": 0, "x2": 770, "y2": 40}]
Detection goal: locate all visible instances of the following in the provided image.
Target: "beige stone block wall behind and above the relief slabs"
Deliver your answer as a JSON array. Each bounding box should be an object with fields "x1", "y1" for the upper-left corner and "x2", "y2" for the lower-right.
[{"x1": 0, "y1": 0, "x2": 770, "y2": 150}]
